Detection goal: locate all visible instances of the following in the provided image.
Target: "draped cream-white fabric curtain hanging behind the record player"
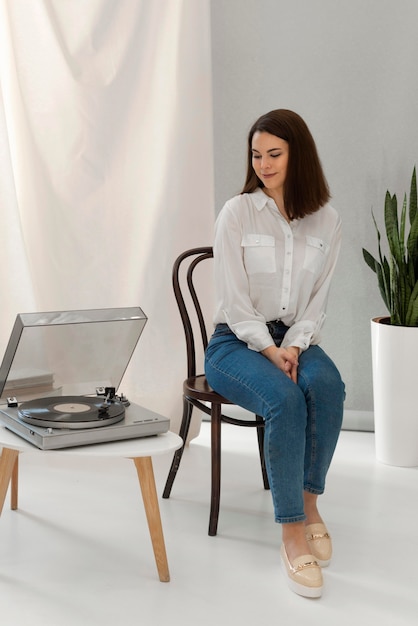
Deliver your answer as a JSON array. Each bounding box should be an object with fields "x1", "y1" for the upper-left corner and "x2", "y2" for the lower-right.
[{"x1": 0, "y1": 0, "x2": 214, "y2": 429}]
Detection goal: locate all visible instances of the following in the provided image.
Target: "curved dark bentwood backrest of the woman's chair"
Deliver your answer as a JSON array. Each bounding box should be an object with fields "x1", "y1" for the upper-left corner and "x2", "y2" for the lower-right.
[{"x1": 173, "y1": 246, "x2": 213, "y2": 378}]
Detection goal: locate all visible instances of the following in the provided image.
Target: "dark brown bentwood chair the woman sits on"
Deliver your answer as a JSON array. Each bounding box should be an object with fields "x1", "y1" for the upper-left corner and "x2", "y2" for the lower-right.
[{"x1": 163, "y1": 247, "x2": 269, "y2": 536}]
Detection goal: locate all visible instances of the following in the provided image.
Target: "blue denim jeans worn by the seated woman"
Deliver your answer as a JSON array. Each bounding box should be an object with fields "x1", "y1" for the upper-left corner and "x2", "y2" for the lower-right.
[{"x1": 205, "y1": 322, "x2": 345, "y2": 523}]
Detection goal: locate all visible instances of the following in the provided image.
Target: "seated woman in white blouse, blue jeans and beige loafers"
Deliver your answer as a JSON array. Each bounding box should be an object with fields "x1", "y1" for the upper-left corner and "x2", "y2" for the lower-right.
[{"x1": 205, "y1": 109, "x2": 345, "y2": 597}]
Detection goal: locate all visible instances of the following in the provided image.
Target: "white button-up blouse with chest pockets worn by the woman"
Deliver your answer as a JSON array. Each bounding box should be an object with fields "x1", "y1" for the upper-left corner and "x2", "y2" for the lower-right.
[{"x1": 214, "y1": 189, "x2": 341, "y2": 352}]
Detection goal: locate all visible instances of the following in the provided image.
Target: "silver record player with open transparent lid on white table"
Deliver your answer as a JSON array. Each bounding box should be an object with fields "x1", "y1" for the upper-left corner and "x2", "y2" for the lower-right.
[{"x1": 0, "y1": 307, "x2": 170, "y2": 450}]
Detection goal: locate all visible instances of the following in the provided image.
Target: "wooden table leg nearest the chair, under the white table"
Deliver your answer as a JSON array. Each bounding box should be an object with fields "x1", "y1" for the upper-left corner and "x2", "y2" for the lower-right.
[{"x1": 133, "y1": 456, "x2": 170, "y2": 583}]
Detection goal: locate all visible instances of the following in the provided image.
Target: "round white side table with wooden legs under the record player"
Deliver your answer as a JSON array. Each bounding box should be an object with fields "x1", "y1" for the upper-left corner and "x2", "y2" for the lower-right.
[{"x1": 0, "y1": 423, "x2": 182, "y2": 582}]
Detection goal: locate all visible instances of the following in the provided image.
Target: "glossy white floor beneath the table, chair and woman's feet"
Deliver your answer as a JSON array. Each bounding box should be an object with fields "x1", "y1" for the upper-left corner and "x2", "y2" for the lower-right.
[{"x1": 0, "y1": 423, "x2": 418, "y2": 626}]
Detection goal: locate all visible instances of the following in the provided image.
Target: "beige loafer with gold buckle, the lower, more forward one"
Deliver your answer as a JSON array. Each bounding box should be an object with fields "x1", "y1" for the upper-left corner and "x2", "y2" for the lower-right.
[{"x1": 280, "y1": 544, "x2": 323, "y2": 598}]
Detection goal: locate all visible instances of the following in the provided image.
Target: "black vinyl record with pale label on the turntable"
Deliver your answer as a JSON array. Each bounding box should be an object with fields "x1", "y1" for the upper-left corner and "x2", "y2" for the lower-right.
[{"x1": 18, "y1": 396, "x2": 125, "y2": 429}]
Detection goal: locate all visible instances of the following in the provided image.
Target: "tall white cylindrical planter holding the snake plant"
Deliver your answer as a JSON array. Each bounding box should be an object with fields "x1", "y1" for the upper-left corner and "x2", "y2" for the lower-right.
[{"x1": 371, "y1": 317, "x2": 418, "y2": 467}]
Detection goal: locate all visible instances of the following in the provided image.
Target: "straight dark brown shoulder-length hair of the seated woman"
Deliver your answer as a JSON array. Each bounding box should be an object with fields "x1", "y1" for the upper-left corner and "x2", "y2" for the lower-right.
[{"x1": 241, "y1": 109, "x2": 331, "y2": 219}]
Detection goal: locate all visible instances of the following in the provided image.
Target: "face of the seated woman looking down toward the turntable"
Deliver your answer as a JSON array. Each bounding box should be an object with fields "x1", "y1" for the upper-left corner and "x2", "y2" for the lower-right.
[{"x1": 251, "y1": 131, "x2": 289, "y2": 195}]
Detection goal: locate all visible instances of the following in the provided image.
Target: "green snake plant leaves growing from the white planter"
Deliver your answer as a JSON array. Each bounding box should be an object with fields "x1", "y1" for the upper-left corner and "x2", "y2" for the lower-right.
[{"x1": 363, "y1": 167, "x2": 418, "y2": 326}]
